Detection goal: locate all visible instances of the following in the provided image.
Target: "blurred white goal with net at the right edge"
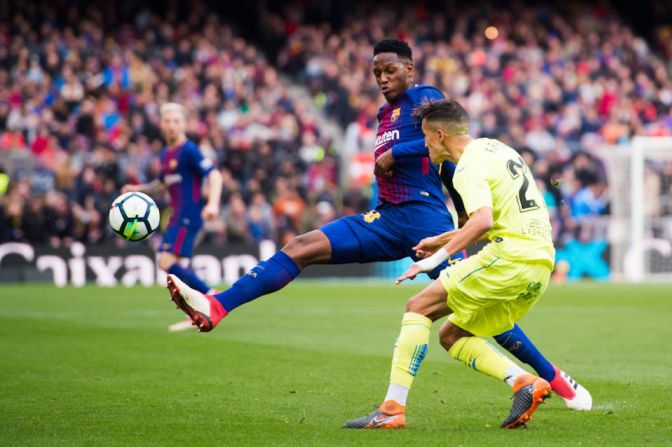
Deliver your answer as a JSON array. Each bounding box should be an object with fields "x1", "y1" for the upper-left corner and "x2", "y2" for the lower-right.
[{"x1": 599, "y1": 137, "x2": 672, "y2": 282}]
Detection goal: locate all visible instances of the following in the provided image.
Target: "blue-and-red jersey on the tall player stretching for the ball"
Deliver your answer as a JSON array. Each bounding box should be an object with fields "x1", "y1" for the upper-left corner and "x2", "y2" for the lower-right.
[{"x1": 375, "y1": 84, "x2": 445, "y2": 208}]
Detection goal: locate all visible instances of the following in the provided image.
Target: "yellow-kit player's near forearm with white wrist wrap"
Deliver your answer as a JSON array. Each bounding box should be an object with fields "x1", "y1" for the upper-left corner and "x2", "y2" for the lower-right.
[{"x1": 395, "y1": 206, "x2": 494, "y2": 284}]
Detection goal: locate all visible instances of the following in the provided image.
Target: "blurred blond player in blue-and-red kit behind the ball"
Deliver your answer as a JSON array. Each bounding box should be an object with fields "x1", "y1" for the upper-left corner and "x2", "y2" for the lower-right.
[{"x1": 122, "y1": 103, "x2": 222, "y2": 331}]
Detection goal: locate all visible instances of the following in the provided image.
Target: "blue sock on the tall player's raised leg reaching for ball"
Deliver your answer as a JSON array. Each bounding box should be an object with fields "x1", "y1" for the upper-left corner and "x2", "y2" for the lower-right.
[{"x1": 215, "y1": 251, "x2": 301, "y2": 312}]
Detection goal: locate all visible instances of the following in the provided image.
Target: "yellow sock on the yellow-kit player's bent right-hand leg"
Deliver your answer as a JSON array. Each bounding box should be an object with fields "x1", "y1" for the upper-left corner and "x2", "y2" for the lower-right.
[{"x1": 448, "y1": 337, "x2": 524, "y2": 380}]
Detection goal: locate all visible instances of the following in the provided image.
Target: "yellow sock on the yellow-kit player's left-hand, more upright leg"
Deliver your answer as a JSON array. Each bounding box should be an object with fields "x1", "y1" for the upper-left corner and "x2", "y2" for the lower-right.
[{"x1": 390, "y1": 312, "x2": 432, "y2": 388}]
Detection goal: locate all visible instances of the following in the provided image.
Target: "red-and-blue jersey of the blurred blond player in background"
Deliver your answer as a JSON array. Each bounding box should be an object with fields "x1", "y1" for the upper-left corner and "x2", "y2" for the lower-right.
[{"x1": 159, "y1": 140, "x2": 213, "y2": 227}]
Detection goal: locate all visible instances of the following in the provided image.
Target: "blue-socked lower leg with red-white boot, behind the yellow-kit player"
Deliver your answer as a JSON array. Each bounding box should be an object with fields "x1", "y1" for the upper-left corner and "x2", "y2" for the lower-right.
[{"x1": 494, "y1": 324, "x2": 593, "y2": 410}]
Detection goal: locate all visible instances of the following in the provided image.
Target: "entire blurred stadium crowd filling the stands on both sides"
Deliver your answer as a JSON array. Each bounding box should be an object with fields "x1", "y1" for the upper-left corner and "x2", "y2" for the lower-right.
[{"x1": 0, "y1": 2, "x2": 672, "y2": 260}]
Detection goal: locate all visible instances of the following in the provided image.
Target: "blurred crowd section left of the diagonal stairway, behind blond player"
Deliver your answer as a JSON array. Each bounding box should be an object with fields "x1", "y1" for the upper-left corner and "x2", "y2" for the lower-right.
[{"x1": 0, "y1": 2, "x2": 346, "y2": 246}]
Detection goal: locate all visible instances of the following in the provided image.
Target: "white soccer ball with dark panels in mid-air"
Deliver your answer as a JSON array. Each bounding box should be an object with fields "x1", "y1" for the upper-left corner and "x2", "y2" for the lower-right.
[{"x1": 109, "y1": 192, "x2": 160, "y2": 242}]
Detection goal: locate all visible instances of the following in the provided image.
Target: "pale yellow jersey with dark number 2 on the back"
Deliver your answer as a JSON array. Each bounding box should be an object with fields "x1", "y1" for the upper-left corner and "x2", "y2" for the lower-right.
[{"x1": 453, "y1": 138, "x2": 555, "y2": 268}]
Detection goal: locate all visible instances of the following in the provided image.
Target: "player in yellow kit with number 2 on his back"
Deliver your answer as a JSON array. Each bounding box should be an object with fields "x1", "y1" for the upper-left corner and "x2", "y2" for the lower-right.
[{"x1": 344, "y1": 99, "x2": 555, "y2": 428}]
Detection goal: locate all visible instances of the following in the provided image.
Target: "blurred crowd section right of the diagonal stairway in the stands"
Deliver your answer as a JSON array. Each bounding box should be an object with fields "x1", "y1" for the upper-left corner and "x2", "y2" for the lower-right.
[{"x1": 264, "y1": 2, "x2": 672, "y2": 248}]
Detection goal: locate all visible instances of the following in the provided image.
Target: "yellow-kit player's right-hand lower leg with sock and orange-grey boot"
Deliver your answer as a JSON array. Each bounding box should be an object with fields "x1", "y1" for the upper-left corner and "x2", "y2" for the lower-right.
[{"x1": 440, "y1": 321, "x2": 551, "y2": 428}]
